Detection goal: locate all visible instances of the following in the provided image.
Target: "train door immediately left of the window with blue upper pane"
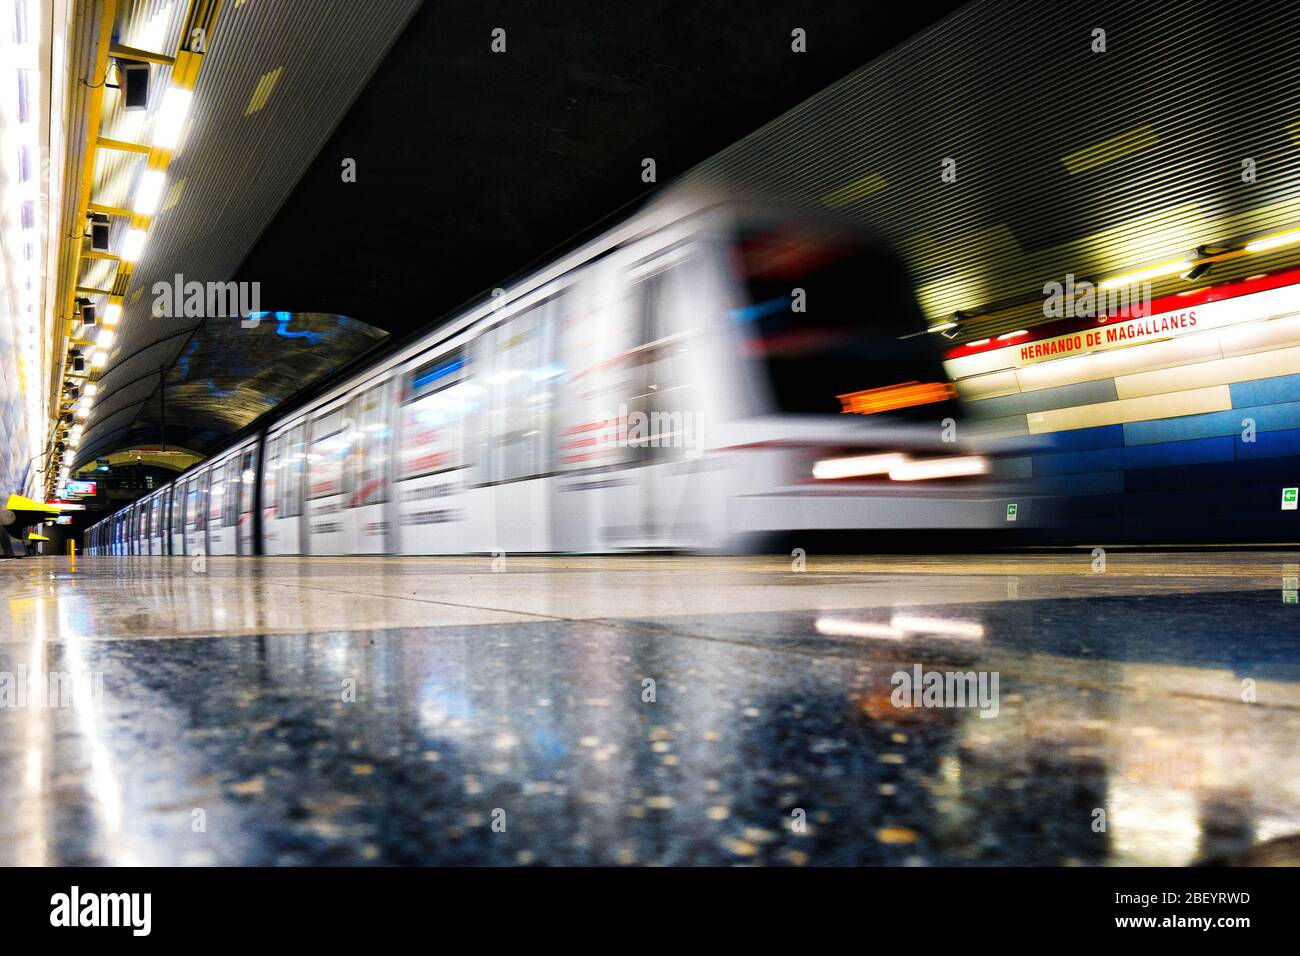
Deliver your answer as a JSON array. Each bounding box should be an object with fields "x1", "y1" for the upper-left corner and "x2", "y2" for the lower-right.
[{"x1": 345, "y1": 378, "x2": 395, "y2": 554}]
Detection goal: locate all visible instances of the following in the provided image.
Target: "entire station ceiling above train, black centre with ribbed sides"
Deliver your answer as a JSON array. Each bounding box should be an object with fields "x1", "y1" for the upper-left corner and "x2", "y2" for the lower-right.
[{"x1": 65, "y1": 0, "x2": 1300, "y2": 473}]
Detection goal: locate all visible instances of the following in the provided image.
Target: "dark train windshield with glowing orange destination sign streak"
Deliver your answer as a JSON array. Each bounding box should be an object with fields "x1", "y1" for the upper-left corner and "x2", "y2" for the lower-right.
[{"x1": 731, "y1": 226, "x2": 952, "y2": 418}]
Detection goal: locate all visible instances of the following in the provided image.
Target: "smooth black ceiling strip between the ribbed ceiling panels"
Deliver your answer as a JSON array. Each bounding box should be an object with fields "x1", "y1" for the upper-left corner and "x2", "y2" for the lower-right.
[{"x1": 237, "y1": 0, "x2": 959, "y2": 334}]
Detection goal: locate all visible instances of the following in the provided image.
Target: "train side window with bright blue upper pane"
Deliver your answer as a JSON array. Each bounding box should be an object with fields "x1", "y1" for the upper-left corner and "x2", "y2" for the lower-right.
[{"x1": 398, "y1": 349, "x2": 478, "y2": 481}]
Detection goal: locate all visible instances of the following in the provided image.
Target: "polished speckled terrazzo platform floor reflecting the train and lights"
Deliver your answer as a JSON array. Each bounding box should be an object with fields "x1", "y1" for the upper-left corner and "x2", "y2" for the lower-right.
[{"x1": 0, "y1": 550, "x2": 1300, "y2": 865}]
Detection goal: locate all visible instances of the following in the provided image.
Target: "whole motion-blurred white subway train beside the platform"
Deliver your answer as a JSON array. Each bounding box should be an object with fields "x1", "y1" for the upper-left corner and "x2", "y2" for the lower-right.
[{"x1": 87, "y1": 200, "x2": 1014, "y2": 555}]
